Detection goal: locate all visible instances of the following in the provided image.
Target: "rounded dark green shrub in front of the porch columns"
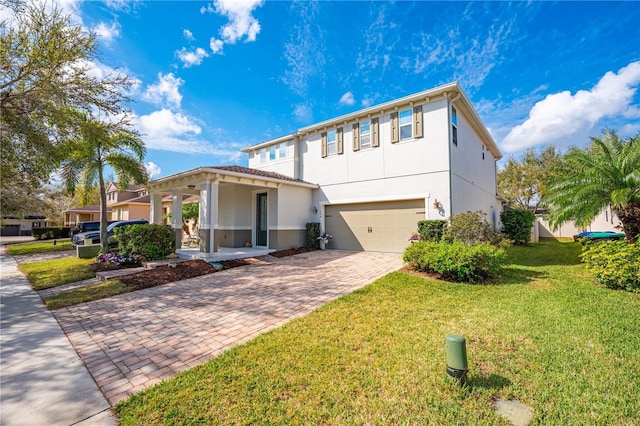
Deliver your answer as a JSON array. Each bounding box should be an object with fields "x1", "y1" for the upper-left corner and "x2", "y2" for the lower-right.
[{"x1": 113, "y1": 225, "x2": 175, "y2": 260}]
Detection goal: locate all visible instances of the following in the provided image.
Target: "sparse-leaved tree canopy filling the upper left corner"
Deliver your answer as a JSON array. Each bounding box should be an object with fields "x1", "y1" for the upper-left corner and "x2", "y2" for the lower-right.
[{"x1": 0, "y1": 0, "x2": 131, "y2": 210}]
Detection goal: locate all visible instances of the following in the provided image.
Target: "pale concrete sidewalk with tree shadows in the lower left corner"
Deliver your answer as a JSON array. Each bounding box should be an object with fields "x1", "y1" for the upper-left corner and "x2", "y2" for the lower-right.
[{"x1": 0, "y1": 246, "x2": 115, "y2": 426}]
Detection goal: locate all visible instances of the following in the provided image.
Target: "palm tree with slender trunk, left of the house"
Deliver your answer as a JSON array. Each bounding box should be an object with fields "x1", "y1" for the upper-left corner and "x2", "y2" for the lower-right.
[{"x1": 61, "y1": 112, "x2": 148, "y2": 252}]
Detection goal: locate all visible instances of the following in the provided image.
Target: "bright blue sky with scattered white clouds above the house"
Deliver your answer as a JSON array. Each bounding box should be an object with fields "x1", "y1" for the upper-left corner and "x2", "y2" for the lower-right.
[{"x1": 28, "y1": 0, "x2": 640, "y2": 177}]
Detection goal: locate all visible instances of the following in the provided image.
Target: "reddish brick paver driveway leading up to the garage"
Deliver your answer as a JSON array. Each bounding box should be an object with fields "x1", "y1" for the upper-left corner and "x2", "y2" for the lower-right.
[{"x1": 54, "y1": 250, "x2": 402, "y2": 404}]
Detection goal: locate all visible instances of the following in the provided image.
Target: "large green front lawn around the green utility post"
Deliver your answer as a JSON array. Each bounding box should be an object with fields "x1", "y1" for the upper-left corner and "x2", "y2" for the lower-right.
[{"x1": 115, "y1": 241, "x2": 640, "y2": 425}]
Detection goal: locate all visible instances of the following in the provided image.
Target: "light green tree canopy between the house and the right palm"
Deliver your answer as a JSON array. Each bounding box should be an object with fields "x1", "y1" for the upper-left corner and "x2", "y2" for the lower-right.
[{"x1": 498, "y1": 146, "x2": 562, "y2": 211}]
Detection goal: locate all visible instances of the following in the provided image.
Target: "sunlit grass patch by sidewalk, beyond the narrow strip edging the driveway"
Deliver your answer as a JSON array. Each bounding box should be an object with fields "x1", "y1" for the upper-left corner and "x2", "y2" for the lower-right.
[{"x1": 19, "y1": 257, "x2": 96, "y2": 291}]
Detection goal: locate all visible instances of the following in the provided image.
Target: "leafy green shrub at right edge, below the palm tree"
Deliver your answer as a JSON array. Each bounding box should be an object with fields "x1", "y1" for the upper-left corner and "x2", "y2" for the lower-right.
[{"x1": 581, "y1": 241, "x2": 640, "y2": 293}]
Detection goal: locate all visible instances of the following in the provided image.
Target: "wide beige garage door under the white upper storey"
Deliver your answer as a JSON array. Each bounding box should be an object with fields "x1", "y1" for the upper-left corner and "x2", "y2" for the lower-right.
[{"x1": 325, "y1": 199, "x2": 425, "y2": 253}]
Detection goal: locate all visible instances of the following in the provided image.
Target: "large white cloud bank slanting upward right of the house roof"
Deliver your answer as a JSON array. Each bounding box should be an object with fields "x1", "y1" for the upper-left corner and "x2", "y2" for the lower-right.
[{"x1": 501, "y1": 62, "x2": 640, "y2": 152}]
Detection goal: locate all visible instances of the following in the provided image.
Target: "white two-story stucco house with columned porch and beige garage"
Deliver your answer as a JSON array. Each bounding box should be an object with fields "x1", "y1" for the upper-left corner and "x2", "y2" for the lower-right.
[{"x1": 149, "y1": 83, "x2": 502, "y2": 256}]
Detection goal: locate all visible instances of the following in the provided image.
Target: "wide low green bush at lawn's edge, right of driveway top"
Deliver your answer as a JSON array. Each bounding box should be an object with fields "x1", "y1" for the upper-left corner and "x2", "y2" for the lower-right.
[{"x1": 403, "y1": 241, "x2": 506, "y2": 283}]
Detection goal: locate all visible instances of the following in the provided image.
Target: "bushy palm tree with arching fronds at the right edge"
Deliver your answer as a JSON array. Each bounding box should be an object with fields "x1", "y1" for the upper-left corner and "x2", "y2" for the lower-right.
[{"x1": 546, "y1": 129, "x2": 640, "y2": 242}]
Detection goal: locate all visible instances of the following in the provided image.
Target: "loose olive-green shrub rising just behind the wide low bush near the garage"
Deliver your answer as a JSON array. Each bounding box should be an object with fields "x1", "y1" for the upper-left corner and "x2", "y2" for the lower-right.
[{"x1": 442, "y1": 211, "x2": 509, "y2": 247}]
